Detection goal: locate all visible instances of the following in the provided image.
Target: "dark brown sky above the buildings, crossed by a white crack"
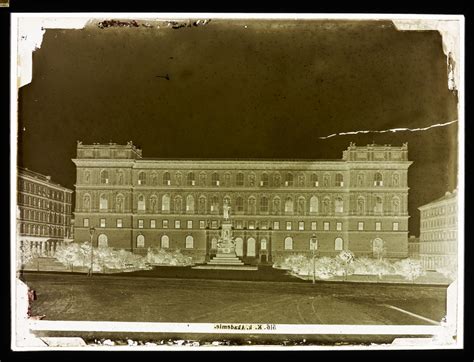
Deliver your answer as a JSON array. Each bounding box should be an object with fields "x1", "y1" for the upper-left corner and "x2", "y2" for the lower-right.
[{"x1": 19, "y1": 19, "x2": 457, "y2": 235}]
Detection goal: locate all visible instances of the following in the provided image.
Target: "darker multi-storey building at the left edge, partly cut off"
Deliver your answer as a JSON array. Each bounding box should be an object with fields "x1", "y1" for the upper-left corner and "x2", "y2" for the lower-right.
[{"x1": 17, "y1": 167, "x2": 73, "y2": 255}]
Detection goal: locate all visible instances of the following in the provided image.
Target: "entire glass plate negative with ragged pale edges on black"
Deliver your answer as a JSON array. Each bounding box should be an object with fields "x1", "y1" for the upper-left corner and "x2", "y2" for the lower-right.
[{"x1": 11, "y1": 14, "x2": 464, "y2": 350}]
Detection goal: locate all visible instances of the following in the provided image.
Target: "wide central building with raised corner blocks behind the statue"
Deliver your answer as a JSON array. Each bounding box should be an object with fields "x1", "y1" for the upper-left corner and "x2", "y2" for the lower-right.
[{"x1": 73, "y1": 142, "x2": 412, "y2": 263}]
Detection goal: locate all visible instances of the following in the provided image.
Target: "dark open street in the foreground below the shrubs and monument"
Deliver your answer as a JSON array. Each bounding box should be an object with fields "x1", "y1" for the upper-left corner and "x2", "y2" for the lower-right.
[{"x1": 20, "y1": 273, "x2": 446, "y2": 325}]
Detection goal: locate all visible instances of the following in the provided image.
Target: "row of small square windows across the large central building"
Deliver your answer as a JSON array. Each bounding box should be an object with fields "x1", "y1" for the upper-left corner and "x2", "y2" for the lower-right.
[{"x1": 83, "y1": 218, "x2": 400, "y2": 231}]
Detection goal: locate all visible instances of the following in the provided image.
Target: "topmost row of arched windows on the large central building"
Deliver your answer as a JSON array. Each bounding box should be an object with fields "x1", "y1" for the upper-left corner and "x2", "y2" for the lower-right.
[{"x1": 90, "y1": 170, "x2": 400, "y2": 187}]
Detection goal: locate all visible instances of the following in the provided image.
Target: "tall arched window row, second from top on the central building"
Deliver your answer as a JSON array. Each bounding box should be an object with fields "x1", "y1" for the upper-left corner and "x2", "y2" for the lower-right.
[{"x1": 83, "y1": 194, "x2": 401, "y2": 215}]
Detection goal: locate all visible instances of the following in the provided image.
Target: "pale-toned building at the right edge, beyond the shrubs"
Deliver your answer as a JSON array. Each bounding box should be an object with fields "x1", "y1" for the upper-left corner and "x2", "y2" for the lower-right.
[{"x1": 418, "y1": 190, "x2": 458, "y2": 270}]
